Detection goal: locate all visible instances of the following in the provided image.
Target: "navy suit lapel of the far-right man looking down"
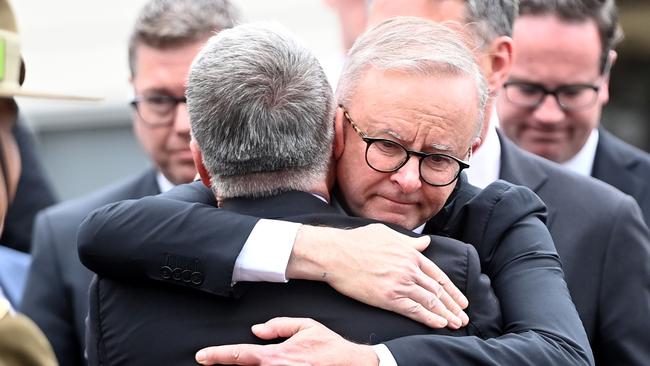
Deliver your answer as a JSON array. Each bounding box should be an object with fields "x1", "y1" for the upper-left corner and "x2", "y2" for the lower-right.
[{"x1": 592, "y1": 128, "x2": 644, "y2": 197}]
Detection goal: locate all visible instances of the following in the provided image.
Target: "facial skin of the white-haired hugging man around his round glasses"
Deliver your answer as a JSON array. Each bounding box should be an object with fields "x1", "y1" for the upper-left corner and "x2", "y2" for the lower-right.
[{"x1": 337, "y1": 70, "x2": 478, "y2": 229}]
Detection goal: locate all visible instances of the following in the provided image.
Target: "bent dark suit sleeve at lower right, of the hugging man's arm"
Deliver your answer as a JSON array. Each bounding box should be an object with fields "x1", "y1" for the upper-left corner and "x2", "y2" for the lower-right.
[{"x1": 386, "y1": 182, "x2": 593, "y2": 366}]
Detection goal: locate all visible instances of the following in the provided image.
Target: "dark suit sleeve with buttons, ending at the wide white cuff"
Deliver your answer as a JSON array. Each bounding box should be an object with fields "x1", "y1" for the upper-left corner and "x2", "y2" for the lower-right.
[{"x1": 77, "y1": 182, "x2": 258, "y2": 296}]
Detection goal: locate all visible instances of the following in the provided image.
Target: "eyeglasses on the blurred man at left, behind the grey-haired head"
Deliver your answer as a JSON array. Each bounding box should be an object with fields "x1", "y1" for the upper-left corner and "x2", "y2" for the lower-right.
[{"x1": 131, "y1": 94, "x2": 187, "y2": 127}]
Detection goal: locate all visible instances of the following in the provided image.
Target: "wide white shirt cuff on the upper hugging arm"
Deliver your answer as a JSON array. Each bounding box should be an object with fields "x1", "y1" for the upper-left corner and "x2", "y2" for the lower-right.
[{"x1": 232, "y1": 219, "x2": 302, "y2": 284}]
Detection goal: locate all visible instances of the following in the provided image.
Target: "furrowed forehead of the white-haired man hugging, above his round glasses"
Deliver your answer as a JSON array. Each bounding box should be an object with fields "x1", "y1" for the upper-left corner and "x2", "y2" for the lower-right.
[{"x1": 349, "y1": 69, "x2": 479, "y2": 153}]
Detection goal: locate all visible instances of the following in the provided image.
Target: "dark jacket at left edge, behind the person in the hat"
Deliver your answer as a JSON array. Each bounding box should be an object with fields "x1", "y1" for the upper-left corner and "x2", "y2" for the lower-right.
[{"x1": 0, "y1": 115, "x2": 57, "y2": 253}]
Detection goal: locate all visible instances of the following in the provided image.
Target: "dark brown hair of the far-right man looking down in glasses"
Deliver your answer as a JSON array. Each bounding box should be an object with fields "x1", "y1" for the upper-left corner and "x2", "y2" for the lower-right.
[{"x1": 519, "y1": 0, "x2": 624, "y2": 73}]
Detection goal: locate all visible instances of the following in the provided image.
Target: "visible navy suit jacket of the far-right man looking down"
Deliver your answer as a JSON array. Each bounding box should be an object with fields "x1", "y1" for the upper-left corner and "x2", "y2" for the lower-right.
[{"x1": 591, "y1": 128, "x2": 650, "y2": 225}]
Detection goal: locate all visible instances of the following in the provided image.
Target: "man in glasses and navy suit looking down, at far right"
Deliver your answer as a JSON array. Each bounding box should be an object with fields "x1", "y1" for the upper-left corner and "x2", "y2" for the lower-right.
[{"x1": 497, "y1": 0, "x2": 650, "y2": 223}]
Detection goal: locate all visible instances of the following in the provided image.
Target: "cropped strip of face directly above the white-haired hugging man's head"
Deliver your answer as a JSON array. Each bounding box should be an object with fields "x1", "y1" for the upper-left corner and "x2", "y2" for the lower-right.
[{"x1": 368, "y1": 0, "x2": 465, "y2": 26}]
